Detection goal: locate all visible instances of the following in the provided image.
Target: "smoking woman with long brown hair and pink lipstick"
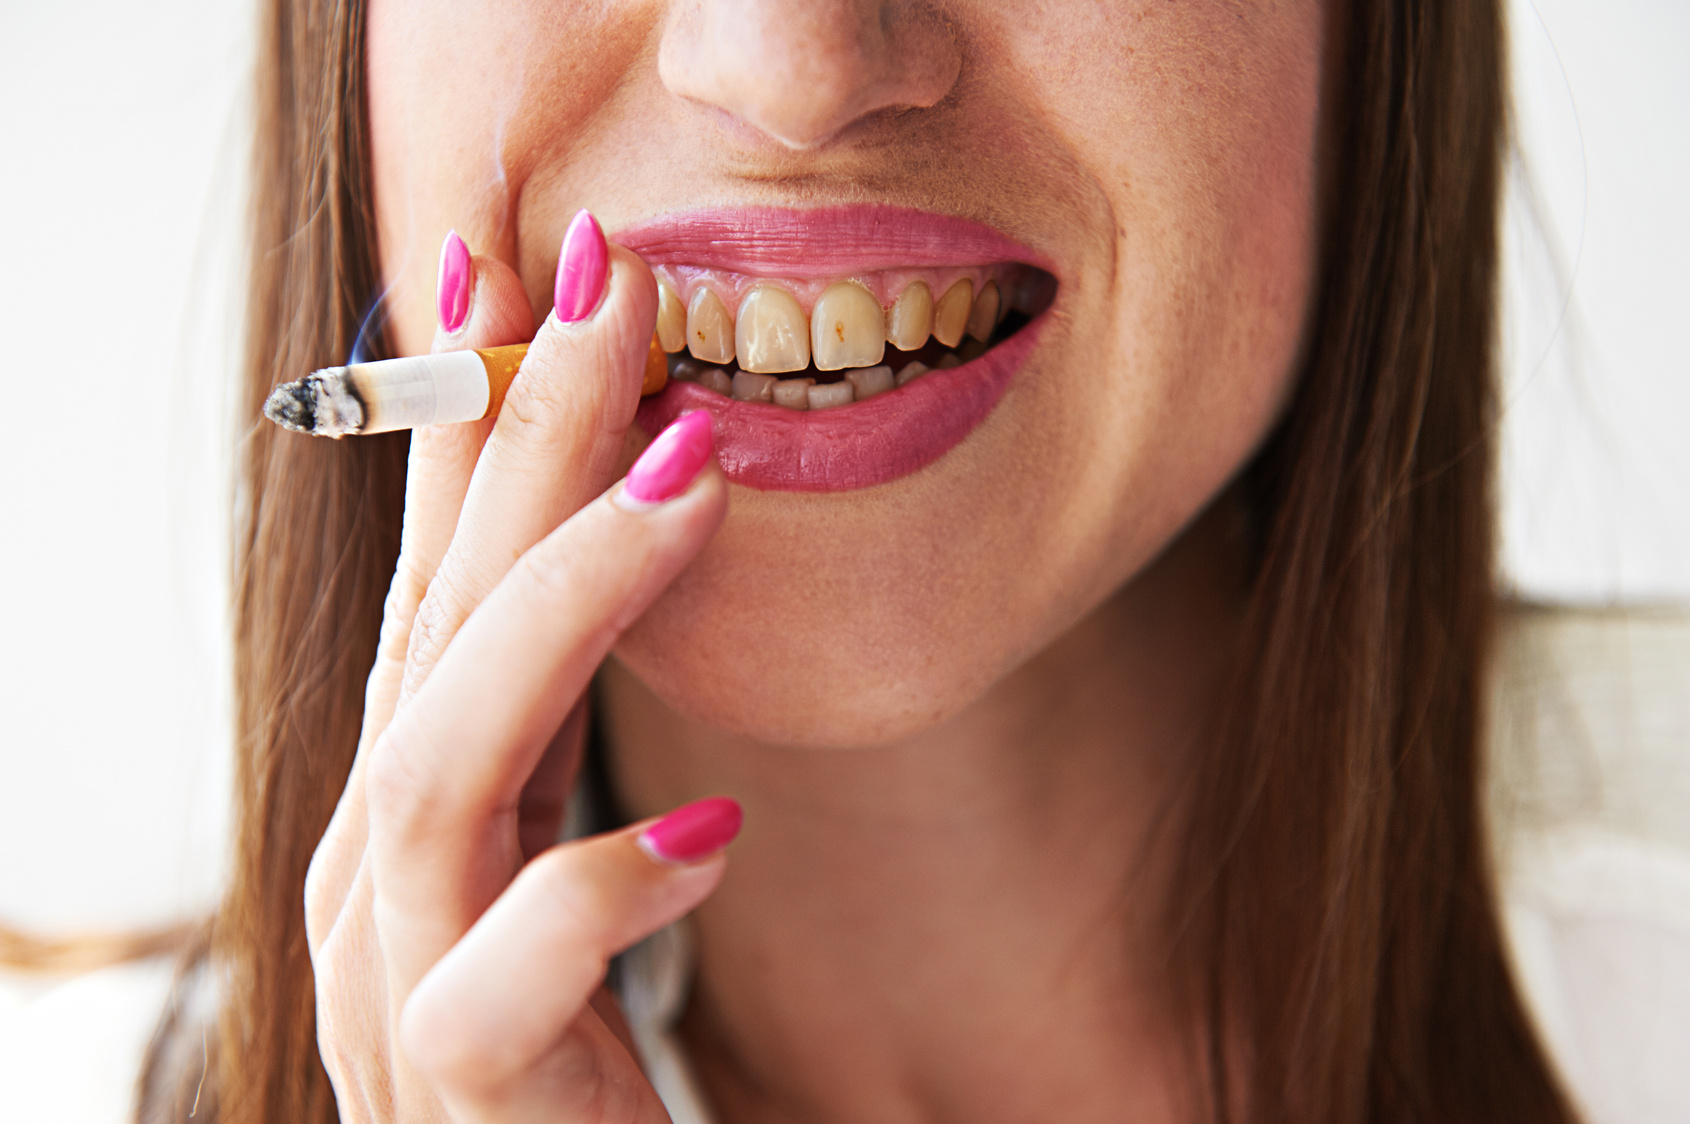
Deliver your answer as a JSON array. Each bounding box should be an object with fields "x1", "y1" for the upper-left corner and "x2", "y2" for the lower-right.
[{"x1": 144, "y1": 0, "x2": 1570, "y2": 1122}]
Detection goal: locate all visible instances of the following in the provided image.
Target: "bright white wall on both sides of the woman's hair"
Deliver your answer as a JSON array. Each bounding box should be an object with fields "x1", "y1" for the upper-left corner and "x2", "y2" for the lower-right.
[{"x1": 0, "y1": 0, "x2": 1690, "y2": 1115}]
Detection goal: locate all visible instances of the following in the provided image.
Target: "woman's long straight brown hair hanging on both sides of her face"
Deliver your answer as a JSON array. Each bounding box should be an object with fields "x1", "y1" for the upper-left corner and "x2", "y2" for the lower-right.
[{"x1": 144, "y1": 0, "x2": 1572, "y2": 1124}]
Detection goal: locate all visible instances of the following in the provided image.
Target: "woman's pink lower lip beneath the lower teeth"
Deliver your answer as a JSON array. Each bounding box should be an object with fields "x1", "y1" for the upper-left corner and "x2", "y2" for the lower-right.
[{"x1": 637, "y1": 318, "x2": 1043, "y2": 492}]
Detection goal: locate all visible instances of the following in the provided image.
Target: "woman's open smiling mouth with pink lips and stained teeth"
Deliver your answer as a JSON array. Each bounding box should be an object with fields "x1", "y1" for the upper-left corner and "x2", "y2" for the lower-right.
[{"x1": 628, "y1": 206, "x2": 1056, "y2": 490}]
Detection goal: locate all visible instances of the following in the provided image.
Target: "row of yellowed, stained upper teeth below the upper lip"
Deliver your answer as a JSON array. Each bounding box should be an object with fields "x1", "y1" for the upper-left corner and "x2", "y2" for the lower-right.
[{"x1": 657, "y1": 269, "x2": 1038, "y2": 375}]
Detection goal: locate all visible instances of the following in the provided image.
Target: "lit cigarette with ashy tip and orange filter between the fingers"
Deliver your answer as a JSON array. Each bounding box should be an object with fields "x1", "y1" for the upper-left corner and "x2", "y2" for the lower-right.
[{"x1": 264, "y1": 336, "x2": 669, "y2": 438}]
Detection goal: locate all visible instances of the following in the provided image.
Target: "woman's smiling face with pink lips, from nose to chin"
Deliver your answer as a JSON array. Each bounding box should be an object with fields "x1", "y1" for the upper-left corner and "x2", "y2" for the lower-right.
[{"x1": 368, "y1": 0, "x2": 1323, "y2": 744}]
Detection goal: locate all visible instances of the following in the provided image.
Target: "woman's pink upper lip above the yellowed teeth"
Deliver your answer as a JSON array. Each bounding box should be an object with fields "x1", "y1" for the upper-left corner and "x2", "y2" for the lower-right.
[{"x1": 612, "y1": 205, "x2": 1056, "y2": 279}]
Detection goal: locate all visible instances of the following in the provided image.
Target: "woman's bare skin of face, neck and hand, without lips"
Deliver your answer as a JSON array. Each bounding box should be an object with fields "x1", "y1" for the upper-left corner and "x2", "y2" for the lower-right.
[{"x1": 308, "y1": 0, "x2": 1323, "y2": 1122}]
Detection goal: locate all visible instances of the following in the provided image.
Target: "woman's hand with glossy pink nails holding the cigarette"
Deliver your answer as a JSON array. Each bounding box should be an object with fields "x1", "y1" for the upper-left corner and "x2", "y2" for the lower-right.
[{"x1": 306, "y1": 220, "x2": 739, "y2": 1124}]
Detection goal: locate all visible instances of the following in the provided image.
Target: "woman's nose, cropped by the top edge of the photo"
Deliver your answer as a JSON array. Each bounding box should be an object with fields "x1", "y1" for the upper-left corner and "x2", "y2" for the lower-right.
[{"x1": 657, "y1": 0, "x2": 962, "y2": 149}]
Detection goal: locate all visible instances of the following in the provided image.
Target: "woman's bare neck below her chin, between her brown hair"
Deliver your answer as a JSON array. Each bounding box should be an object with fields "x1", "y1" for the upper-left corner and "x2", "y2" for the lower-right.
[{"x1": 603, "y1": 500, "x2": 1237, "y2": 1124}]
